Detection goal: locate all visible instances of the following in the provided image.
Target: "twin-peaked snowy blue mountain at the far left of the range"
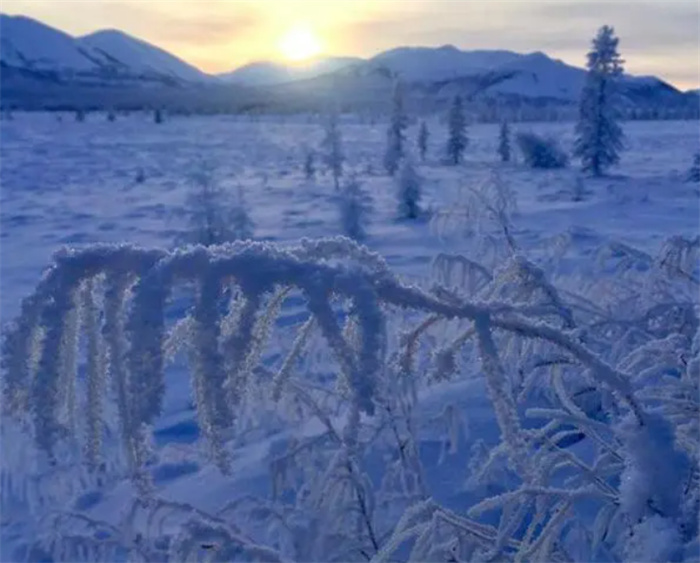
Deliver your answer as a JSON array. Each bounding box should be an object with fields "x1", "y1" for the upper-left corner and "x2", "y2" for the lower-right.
[{"x1": 0, "y1": 14, "x2": 211, "y2": 81}]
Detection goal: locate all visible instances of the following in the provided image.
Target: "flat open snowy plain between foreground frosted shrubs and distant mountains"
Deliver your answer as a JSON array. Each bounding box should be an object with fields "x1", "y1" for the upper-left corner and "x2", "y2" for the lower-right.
[{"x1": 0, "y1": 114, "x2": 700, "y2": 320}]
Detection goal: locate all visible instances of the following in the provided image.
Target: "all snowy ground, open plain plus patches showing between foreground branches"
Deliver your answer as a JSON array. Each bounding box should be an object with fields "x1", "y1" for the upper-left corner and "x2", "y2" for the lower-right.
[{"x1": 0, "y1": 114, "x2": 700, "y2": 560}]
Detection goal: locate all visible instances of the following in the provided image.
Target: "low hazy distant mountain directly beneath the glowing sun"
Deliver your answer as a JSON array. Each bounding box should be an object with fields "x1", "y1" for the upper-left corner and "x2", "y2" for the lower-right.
[{"x1": 217, "y1": 57, "x2": 363, "y2": 86}]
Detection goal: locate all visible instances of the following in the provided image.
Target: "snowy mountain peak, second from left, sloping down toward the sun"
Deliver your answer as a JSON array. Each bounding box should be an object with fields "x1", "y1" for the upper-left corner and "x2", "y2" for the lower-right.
[{"x1": 78, "y1": 29, "x2": 211, "y2": 81}]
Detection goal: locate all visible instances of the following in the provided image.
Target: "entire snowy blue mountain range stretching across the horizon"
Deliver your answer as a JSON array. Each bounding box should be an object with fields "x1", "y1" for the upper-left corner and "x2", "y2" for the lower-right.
[{"x1": 0, "y1": 14, "x2": 698, "y2": 119}]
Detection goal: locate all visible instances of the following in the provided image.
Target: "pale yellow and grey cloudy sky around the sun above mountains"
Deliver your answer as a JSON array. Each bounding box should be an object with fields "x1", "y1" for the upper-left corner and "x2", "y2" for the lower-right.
[{"x1": 0, "y1": 0, "x2": 700, "y2": 89}]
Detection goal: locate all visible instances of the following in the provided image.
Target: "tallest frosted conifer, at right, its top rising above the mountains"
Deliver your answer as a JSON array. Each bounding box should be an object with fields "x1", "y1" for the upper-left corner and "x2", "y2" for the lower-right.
[{"x1": 574, "y1": 25, "x2": 624, "y2": 176}]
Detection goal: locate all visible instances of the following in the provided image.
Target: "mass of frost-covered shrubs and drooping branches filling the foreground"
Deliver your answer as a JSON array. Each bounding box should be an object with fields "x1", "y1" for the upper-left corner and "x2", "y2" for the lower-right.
[{"x1": 0, "y1": 231, "x2": 700, "y2": 562}]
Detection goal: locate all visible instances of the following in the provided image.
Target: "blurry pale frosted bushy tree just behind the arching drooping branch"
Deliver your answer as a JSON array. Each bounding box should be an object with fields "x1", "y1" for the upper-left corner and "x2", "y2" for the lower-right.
[{"x1": 179, "y1": 162, "x2": 255, "y2": 246}]
